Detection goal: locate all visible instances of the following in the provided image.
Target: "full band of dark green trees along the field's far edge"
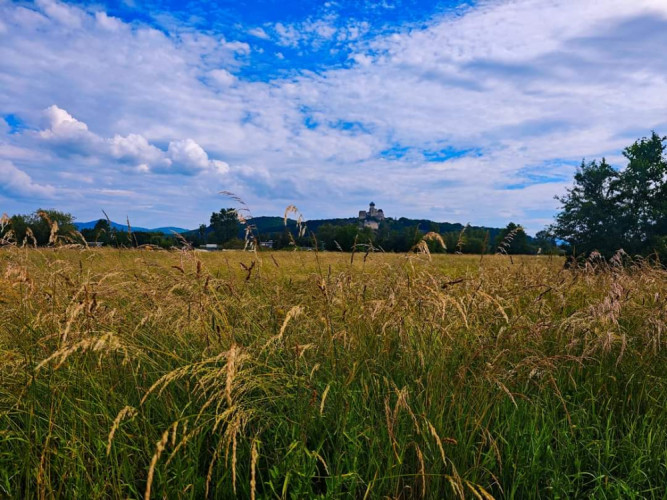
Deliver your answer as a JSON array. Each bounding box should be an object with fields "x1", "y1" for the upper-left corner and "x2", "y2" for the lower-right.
[{"x1": 0, "y1": 132, "x2": 667, "y2": 262}]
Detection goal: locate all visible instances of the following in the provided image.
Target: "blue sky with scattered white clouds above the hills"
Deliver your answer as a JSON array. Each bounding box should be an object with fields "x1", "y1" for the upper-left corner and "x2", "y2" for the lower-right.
[{"x1": 0, "y1": 0, "x2": 667, "y2": 230}]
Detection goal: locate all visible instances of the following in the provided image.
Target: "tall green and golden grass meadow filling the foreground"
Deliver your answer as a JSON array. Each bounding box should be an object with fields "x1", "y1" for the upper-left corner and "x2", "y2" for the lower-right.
[{"x1": 0, "y1": 248, "x2": 667, "y2": 499}]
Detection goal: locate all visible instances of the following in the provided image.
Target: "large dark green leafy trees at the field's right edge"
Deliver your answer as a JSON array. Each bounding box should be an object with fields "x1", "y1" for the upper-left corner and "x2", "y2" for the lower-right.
[{"x1": 551, "y1": 132, "x2": 667, "y2": 260}]
